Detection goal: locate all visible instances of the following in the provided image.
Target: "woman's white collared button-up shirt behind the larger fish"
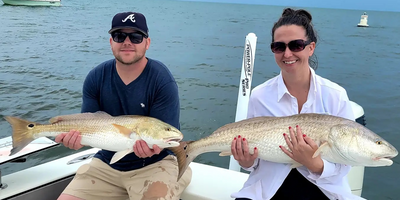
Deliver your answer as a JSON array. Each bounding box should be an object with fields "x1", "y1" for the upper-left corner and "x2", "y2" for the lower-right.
[{"x1": 231, "y1": 68, "x2": 364, "y2": 200}]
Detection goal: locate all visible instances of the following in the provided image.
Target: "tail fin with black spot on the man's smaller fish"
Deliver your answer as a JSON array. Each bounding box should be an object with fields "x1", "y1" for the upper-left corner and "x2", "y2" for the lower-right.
[{"x1": 4, "y1": 116, "x2": 40, "y2": 156}]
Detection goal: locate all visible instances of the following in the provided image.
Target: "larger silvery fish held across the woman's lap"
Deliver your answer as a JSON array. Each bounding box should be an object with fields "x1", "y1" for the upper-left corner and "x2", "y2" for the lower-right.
[{"x1": 172, "y1": 113, "x2": 398, "y2": 180}]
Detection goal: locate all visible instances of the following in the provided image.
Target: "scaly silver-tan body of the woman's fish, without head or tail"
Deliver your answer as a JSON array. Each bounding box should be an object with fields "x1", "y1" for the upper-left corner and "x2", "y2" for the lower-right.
[{"x1": 188, "y1": 112, "x2": 345, "y2": 163}]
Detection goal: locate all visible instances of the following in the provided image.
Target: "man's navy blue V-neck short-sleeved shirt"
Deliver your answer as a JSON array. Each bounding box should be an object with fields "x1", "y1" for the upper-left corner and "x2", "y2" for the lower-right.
[{"x1": 81, "y1": 58, "x2": 180, "y2": 171}]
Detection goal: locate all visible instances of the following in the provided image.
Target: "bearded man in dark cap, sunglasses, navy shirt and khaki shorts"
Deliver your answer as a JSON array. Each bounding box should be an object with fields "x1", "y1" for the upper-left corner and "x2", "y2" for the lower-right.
[{"x1": 56, "y1": 12, "x2": 191, "y2": 200}]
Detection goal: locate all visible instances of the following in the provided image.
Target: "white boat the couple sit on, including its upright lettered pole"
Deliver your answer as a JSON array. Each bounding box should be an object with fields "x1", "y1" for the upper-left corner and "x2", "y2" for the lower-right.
[{"x1": 0, "y1": 33, "x2": 365, "y2": 200}]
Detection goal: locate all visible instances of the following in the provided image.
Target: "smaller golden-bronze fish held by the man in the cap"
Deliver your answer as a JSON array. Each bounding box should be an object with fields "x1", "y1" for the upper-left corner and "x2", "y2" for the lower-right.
[{"x1": 5, "y1": 111, "x2": 183, "y2": 164}]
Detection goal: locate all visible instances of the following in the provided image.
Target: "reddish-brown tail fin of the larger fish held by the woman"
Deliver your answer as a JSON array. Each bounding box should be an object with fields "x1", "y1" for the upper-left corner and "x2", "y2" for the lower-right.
[{"x1": 168, "y1": 141, "x2": 196, "y2": 181}]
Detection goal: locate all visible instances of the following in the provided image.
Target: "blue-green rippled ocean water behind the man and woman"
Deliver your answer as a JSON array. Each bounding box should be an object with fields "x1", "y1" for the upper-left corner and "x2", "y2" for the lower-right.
[{"x1": 0, "y1": 0, "x2": 400, "y2": 200}]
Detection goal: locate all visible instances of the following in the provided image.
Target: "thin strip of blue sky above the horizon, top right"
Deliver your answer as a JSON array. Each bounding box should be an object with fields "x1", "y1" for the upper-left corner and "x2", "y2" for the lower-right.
[{"x1": 182, "y1": 0, "x2": 400, "y2": 12}]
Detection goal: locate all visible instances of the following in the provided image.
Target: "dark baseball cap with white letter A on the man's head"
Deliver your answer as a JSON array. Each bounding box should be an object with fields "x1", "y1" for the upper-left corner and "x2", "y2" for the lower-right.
[{"x1": 108, "y1": 12, "x2": 149, "y2": 37}]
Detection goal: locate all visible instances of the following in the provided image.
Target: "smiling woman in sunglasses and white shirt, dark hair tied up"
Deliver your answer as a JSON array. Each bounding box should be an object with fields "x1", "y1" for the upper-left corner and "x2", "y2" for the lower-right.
[{"x1": 232, "y1": 8, "x2": 360, "y2": 200}]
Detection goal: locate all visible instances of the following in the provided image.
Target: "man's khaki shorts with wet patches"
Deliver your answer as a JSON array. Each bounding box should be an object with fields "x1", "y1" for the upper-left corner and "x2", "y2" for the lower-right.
[{"x1": 63, "y1": 155, "x2": 192, "y2": 200}]
